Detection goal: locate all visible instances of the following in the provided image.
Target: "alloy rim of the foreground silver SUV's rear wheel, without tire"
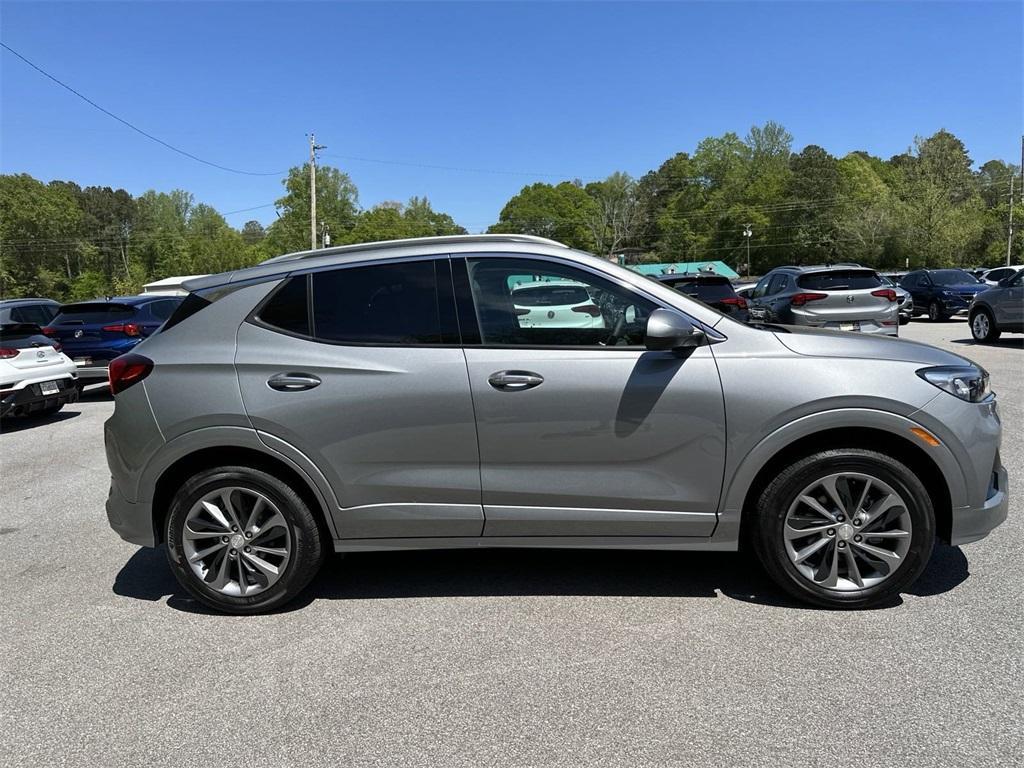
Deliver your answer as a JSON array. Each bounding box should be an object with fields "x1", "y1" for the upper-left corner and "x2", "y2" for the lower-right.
[{"x1": 181, "y1": 486, "x2": 292, "y2": 597}]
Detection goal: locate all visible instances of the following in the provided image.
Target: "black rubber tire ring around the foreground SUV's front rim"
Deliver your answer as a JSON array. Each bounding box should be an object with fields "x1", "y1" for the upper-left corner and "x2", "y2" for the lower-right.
[{"x1": 752, "y1": 447, "x2": 935, "y2": 608}]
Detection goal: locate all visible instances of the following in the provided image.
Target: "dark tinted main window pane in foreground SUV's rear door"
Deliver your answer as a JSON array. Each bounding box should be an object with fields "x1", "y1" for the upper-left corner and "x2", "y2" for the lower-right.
[{"x1": 312, "y1": 261, "x2": 441, "y2": 344}]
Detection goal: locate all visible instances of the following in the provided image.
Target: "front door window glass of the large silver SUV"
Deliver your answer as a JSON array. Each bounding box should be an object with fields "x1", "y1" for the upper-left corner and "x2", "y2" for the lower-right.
[{"x1": 467, "y1": 258, "x2": 657, "y2": 347}]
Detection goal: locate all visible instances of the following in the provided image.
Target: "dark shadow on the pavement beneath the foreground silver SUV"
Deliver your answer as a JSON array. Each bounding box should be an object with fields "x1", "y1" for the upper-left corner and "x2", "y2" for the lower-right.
[{"x1": 114, "y1": 546, "x2": 970, "y2": 613}]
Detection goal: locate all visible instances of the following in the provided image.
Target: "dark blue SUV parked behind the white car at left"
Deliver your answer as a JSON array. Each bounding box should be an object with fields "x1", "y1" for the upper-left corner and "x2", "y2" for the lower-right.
[{"x1": 43, "y1": 296, "x2": 182, "y2": 387}]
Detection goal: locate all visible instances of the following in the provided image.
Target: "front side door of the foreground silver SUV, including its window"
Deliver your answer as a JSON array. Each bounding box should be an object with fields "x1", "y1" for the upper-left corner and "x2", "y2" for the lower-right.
[{"x1": 453, "y1": 255, "x2": 725, "y2": 538}]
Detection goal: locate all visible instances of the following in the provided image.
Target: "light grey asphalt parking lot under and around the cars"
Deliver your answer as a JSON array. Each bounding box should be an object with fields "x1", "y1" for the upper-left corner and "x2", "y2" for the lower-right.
[{"x1": 0, "y1": 321, "x2": 1024, "y2": 766}]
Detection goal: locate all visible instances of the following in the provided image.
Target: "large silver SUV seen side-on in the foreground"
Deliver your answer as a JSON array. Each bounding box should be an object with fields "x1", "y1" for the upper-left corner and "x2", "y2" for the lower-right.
[{"x1": 105, "y1": 236, "x2": 1007, "y2": 613}]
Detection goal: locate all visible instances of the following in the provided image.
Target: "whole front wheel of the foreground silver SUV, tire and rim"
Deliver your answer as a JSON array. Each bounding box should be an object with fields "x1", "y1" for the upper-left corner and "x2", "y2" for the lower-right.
[{"x1": 754, "y1": 449, "x2": 935, "y2": 608}]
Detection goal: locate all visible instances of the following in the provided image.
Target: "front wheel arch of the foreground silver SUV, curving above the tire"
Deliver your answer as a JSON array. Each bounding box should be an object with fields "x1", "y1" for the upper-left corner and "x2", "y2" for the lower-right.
[{"x1": 729, "y1": 412, "x2": 966, "y2": 547}]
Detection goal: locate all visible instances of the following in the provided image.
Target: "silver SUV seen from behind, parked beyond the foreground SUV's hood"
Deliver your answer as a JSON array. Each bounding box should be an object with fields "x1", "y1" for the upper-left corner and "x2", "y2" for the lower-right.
[{"x1": 750, "y1": 264, "x2": 900, "y2": 336}]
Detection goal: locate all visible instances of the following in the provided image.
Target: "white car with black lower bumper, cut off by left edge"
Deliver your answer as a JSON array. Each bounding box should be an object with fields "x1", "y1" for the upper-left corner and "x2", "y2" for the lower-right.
[{"x1": 0, "y1": 324, "x2": 78, "y2": 418}]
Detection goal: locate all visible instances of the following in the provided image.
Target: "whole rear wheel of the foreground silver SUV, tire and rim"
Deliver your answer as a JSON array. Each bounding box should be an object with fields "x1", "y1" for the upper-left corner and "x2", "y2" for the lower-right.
[{"x1": 167, "y1": 467, "x2": 326, "y2": 613}]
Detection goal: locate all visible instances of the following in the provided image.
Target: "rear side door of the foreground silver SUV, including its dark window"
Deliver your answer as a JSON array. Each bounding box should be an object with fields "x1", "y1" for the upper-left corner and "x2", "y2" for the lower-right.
[{"x1": 236, "y1": 257, "x2": 483, "y2": 539}]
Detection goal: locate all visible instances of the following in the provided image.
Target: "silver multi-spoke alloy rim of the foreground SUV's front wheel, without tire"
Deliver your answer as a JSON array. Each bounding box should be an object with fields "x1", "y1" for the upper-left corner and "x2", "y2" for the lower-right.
[{"x1": 783, "y1": 472, "x2": 912, "y2": 592}]
